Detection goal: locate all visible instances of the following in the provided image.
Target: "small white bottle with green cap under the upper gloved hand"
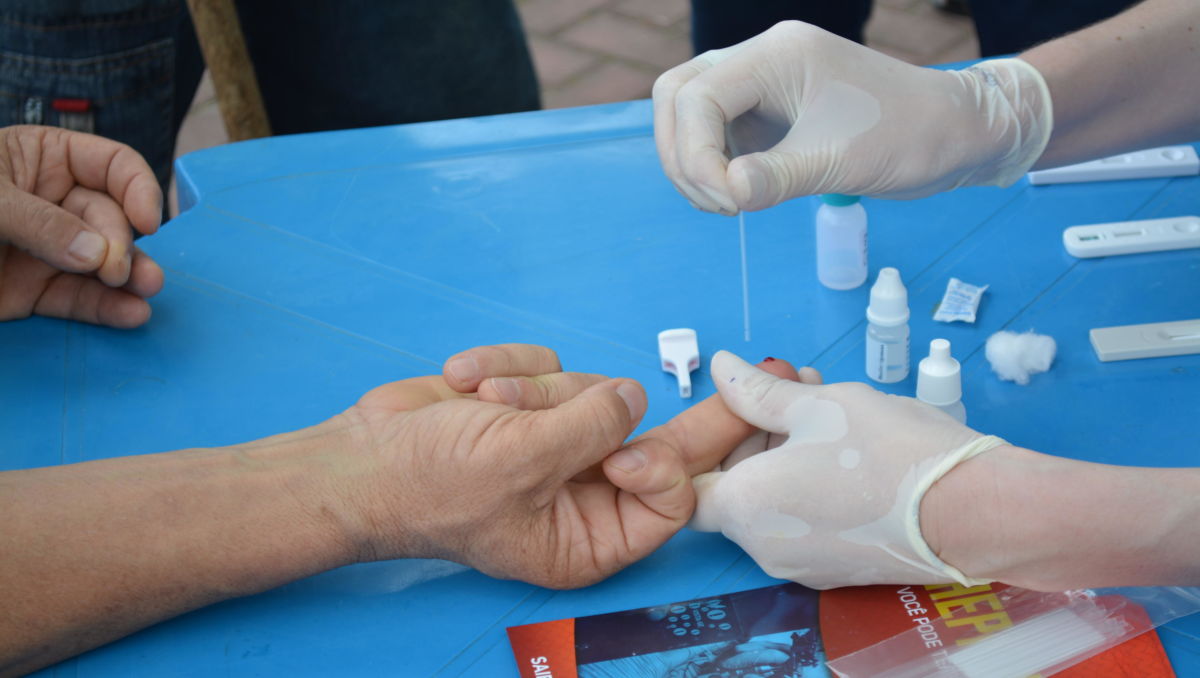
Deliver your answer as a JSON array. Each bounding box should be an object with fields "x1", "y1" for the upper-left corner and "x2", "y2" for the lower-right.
[{"x1": 816, "y1": 193, "x2": 866, "y2": 289}]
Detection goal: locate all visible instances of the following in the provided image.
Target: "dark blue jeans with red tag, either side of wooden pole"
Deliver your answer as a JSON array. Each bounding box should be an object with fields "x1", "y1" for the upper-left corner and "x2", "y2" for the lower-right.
[{"x1": 0, "y1": 0, "x2": 539, "y2": 193}]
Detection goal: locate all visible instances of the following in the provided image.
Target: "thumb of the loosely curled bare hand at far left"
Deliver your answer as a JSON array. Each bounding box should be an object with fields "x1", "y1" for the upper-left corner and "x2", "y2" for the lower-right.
[{"x1": 0, "y1": 185, "x2": 108, "y2": 274}]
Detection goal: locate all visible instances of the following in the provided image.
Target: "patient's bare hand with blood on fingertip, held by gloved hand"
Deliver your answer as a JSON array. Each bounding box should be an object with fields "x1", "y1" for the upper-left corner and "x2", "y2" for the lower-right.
[{"x1": 338, "y1": 344, "x2": 796, "y2": 588}]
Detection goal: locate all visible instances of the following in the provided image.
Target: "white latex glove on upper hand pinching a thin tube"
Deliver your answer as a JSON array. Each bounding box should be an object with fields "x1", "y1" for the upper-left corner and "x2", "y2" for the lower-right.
[{"x1": 654, "y1": 22, "x2": 1052, "y2": 215}]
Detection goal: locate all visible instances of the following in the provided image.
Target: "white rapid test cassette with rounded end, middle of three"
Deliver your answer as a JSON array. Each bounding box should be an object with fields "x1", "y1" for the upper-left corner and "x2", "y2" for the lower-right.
[{"x1": 1062, "y1": 216, "x2": 1200, "y2": 258}]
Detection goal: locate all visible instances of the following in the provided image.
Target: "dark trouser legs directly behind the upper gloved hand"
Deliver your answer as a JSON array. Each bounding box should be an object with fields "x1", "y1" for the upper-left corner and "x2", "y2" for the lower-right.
[{"x1": 691, "y1": 0, "x2": 1136, "y2": 56}]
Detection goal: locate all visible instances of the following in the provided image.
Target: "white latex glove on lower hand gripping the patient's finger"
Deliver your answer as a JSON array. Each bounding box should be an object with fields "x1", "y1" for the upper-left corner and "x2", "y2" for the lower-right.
[{"x1": 691, "y1": 350, "x2": 1003, "y2": 589}]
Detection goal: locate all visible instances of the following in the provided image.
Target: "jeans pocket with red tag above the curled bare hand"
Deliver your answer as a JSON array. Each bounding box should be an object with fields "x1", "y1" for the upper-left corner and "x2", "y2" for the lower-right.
[{"x1": 0, "y1": 38, "x2": 175, "y2": 185}]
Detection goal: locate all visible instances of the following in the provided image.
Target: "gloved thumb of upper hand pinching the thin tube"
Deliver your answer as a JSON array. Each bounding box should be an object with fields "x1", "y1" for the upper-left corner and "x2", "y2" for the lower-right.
[{"x1": 726, "y1": 146, "x2": 830, "y2": 211}]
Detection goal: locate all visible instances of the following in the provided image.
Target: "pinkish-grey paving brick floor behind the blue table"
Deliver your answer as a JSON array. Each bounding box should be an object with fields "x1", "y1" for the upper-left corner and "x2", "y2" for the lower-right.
[{"x1": 172, "y1": 0, "x2": 979, "y2": 211}]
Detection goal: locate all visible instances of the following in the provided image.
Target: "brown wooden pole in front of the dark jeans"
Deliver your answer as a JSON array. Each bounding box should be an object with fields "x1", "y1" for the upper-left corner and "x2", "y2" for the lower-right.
[{"x1": 187, "y1": 0, "x2": 271, "y2": 142}]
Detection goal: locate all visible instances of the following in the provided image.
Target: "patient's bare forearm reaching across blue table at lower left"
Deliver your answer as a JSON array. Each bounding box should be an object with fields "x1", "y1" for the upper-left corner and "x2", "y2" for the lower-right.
[{"x1": 0, "y1": 427, "x2": 352, "y2": 676}]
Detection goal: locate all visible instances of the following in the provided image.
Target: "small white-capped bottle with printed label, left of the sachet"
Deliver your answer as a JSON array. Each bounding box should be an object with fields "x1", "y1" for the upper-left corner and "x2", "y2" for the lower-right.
[{"x1": 866, "y1": 266, "x2": 908, "y2": 384}]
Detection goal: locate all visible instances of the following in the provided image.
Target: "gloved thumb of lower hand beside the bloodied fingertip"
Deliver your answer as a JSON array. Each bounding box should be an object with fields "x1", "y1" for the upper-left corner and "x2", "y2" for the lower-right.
[{"x1": 710, "y1": 350, "x2": 846, "y2": 434}]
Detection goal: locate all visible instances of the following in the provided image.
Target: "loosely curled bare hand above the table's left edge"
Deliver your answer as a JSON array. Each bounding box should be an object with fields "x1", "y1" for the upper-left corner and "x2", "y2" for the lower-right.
[{"x1": 0, "y1": 125, "x2": 162, "y2": 328}]
